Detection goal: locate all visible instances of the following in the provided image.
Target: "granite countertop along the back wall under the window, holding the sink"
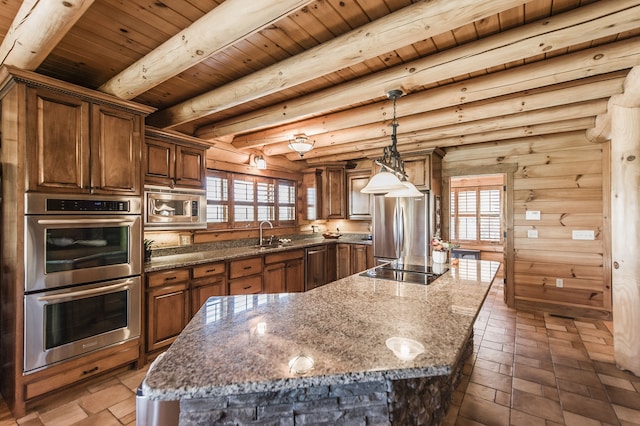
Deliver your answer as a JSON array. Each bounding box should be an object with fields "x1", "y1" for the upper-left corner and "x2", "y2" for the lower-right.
[{"x1": 144, "y1": 234, "x2": 372, "y2": 272}]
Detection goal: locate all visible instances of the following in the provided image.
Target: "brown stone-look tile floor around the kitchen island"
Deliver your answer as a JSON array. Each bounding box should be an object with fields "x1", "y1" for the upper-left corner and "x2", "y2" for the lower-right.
[{"x1": 0, "y1": 284, "x2": 640, "y2": 426}]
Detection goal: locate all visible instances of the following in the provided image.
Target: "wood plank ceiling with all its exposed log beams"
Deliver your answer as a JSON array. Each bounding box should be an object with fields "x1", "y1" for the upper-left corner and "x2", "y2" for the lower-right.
[{"x1": 0, "y1": 0, "x2": 640, "y2": 170}]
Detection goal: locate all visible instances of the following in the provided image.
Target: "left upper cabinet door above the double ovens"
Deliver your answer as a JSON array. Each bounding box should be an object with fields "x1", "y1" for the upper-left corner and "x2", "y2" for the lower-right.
[{"x1": 26, "y1": 88, "x2": 91, "y2": 192}]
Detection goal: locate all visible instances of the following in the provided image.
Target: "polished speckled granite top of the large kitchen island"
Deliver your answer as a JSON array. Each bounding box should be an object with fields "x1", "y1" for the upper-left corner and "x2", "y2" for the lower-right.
[{"x1": 143, "y1": 260, "x2": 499, "y2": 400}]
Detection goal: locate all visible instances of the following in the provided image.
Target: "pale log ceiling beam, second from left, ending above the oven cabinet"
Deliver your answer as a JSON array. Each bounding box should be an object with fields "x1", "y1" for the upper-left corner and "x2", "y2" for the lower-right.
[{"x1": 99, "y1": 0, "x2": 313, "y2": 99}]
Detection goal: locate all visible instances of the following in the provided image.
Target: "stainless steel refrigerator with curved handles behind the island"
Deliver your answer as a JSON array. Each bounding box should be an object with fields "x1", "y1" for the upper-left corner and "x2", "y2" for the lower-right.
[{"x1": 372, "y1": 191, "x2": 430, "y2": 264}]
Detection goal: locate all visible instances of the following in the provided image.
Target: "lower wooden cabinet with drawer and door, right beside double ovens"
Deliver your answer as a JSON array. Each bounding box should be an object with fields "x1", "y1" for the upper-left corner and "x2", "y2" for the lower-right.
[{"x1": 146, "y1": 268, "x2": 190, "y2": 352}]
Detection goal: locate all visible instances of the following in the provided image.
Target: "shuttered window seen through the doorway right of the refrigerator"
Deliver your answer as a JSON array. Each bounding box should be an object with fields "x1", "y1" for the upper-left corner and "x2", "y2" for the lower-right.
[{"x1": 449, "y1": 176, "x2": 503, "y2": 243}]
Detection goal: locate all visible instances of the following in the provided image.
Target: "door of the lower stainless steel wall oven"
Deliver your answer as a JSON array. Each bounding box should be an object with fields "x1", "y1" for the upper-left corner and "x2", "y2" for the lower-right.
[{"x1": 24, "y1": 276, "x2": 140, "y2": 372}]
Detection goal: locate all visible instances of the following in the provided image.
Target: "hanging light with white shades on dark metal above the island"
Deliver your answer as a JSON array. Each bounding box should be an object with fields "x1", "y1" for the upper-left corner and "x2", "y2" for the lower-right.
[{"x1": 360, "y1": 89, "x2": 424, "y2": 197}]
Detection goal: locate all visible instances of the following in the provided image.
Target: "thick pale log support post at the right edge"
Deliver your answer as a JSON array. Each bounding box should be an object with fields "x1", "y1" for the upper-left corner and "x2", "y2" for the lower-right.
[{"x1": 611, "y1": 105, "x2": 640, "y2": 376}]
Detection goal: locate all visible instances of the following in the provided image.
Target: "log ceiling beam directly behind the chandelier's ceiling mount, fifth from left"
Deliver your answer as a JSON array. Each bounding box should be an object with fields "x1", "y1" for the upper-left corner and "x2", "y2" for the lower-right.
[{"x1": 233, "y1": 37, "x2": 640, "y2": 148}]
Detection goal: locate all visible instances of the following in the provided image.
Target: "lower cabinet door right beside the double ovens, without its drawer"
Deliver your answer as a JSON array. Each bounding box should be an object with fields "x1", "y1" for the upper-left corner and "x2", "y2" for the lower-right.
[{"x1": 147, "y1": 283, "x2": 189, "y2": 351}]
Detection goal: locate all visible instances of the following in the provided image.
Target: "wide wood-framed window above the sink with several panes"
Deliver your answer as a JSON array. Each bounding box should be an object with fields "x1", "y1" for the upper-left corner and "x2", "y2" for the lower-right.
[{"x1": 207, "y1": 171, "x2": 296, "y2": 229}]
